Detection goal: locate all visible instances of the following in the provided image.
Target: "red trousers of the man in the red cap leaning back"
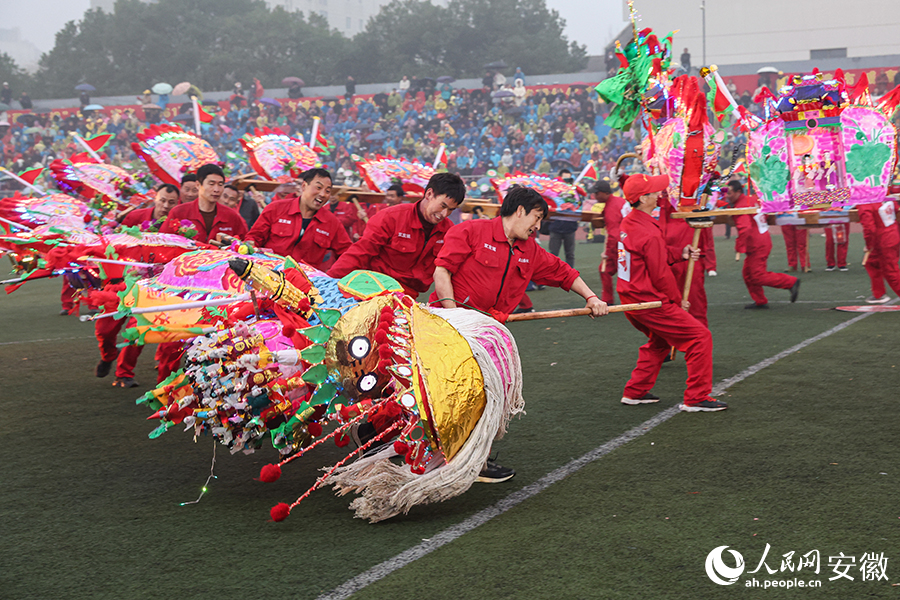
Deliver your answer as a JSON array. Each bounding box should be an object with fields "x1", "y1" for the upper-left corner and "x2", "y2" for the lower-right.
[{"x1": 619, "y1": 294, "x2": 712, "y2": 404}]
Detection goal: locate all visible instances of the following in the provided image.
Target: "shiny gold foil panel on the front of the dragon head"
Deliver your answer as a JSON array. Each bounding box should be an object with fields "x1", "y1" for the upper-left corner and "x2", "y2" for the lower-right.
[{"x1": 411, "y1": 305, "x2": 487, "y2": 462}]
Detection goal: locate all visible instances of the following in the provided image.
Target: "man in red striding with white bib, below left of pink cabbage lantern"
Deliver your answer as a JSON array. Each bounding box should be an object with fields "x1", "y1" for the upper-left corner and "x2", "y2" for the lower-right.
[{"x1": 726, "y1": 181, "x2": 800, "y2": 308}]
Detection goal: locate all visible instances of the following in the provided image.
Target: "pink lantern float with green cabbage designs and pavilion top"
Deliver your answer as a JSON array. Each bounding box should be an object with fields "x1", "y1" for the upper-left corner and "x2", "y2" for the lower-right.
[{"x1": 747, "y1": 73, "x2": 900, "y2": 213}]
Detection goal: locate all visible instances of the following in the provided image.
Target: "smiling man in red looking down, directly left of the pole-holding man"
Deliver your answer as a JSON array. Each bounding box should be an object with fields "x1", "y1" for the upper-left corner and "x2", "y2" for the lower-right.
[{"x1": 328, "y1": 173, "x2": 464, "y2": 302}]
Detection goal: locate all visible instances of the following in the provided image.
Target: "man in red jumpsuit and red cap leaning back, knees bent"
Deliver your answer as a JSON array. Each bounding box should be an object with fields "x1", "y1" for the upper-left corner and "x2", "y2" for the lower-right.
[{"x1": 616, "y1": 174, "x2": 728, "y2": 412}]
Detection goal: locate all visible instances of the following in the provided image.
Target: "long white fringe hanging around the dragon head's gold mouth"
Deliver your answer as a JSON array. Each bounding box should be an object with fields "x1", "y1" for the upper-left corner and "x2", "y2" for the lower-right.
[{"x1": 326, "y1": 308, "x2": 525, "y2": 523}]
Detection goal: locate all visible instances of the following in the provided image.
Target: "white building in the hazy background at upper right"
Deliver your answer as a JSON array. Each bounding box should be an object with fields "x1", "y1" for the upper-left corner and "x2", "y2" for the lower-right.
[{"x1": 623, "y1": 0, "x2": 900, "y2": 67}]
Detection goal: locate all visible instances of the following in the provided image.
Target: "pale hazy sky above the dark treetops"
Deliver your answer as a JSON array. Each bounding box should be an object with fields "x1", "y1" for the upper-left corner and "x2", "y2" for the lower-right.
[{"x1": 0, "y1": 0, "x2": 625, "y2": 54}]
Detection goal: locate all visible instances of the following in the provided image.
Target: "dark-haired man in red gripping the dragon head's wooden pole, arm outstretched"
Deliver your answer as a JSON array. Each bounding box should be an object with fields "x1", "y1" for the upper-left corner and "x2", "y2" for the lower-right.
[{"x1": 430, "y1": 187, "x2": 609, "y2": 483}]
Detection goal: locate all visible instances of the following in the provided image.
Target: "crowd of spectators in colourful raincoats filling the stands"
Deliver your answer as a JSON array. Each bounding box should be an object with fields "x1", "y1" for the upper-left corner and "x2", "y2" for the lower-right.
[{"x1": 0, "y1": 73, "x2": 652, "y2": 192}]
